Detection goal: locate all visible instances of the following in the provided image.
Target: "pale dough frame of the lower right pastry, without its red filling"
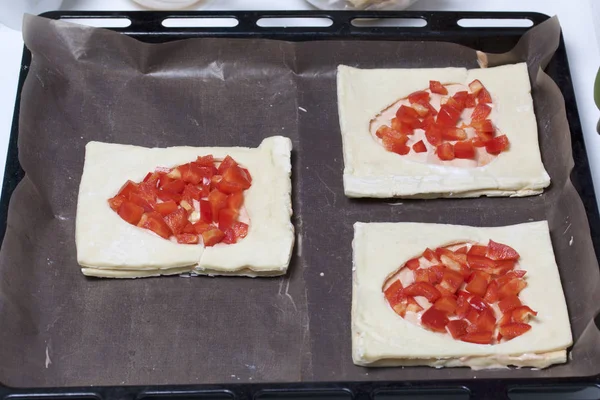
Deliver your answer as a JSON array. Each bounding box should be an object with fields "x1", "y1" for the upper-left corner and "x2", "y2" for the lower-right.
[{"x1": 352, "y1": 221, "x2": 573, "y2": 369}]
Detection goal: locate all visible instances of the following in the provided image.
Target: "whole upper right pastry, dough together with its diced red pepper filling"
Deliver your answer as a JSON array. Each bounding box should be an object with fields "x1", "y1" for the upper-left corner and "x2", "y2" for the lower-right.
[{"x1": 337, "y1": 63, "x2": 550, "y2": 198}]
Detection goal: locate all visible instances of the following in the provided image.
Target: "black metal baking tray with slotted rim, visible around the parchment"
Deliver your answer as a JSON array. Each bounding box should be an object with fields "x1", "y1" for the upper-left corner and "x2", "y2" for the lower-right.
[{"x1": 0, "y1": 11, "x2": 600, "y2": 400}]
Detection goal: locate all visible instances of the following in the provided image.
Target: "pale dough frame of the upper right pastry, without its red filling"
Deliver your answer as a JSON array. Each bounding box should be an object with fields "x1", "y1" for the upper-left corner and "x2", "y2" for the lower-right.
[{"x1": 337, "y1": 63, "x2": 550, "y2": 198}]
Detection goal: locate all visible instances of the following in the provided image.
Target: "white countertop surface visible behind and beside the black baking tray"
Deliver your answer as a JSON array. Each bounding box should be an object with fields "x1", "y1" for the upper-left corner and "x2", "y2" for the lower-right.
[{"x1": 0, "y1": 0, "x2": 600, "y2": 209}]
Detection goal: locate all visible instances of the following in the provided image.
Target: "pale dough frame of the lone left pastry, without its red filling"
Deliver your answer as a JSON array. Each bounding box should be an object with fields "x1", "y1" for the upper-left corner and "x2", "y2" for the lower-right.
[{"x1": 75, "y1": 136, "x2": 294, "y2": 278}]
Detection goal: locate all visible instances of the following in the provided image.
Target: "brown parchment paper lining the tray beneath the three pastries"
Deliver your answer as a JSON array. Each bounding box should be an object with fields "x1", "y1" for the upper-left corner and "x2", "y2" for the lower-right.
[{"x1": 0, "y1": 17, "x2": 600, "y2": 386}]
